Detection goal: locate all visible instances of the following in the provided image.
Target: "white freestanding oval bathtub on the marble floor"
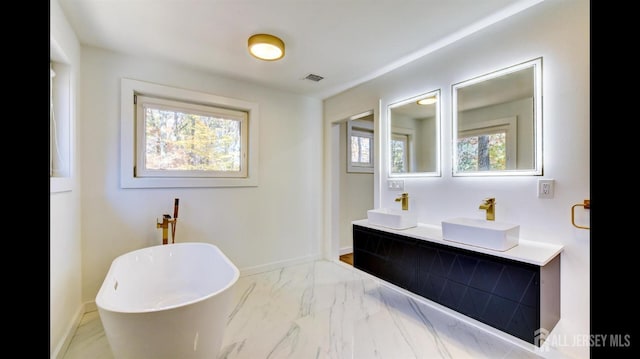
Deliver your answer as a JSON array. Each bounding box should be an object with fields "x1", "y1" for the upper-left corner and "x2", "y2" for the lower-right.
[{"x1": 96, "y1": 242, "x2": 240, "y2": 359}]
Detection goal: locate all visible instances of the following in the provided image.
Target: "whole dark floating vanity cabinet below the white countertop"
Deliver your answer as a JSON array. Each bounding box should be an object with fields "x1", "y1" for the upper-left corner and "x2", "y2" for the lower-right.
[{"x1": 353, "y1": 225, "x2": 560, "y2": 346}]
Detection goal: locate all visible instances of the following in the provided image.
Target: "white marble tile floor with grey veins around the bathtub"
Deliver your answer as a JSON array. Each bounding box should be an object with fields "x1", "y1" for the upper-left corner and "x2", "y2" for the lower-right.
[{"x1": 63, "y1": 260, "x2": 541, "y2": 359}]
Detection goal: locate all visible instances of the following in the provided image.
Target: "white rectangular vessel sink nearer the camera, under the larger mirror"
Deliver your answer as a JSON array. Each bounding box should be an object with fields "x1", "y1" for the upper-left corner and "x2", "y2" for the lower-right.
[{"x1": 442, "y1": 217, "x2": 520, "y2": 252}]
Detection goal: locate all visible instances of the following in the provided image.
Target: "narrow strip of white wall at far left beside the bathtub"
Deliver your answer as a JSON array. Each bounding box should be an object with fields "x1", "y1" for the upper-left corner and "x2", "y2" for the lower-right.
[{"x1": 49, "y1": 0, "x2": 83, "y2": 357}]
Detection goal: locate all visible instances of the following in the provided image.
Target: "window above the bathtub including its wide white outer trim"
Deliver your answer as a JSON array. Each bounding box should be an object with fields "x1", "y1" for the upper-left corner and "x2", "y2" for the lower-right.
[{"x1": 121, "y1": 79, "x2": 258, "y2": 188}]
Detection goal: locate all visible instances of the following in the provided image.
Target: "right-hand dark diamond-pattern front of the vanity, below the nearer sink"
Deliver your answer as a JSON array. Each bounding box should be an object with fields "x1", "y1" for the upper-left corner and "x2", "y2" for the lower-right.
[{"x1": 415, "y1": 241, "x2": 540, "y2": 343}]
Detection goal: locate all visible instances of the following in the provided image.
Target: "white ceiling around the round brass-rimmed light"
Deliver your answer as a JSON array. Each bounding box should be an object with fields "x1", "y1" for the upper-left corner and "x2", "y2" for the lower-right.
[{"x1": 58, "y1": 0, "x2": 542, "y2": 99}]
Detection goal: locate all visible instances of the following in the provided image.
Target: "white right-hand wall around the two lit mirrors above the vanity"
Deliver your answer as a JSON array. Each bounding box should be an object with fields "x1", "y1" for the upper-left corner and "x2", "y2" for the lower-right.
[{"x1": 324, "y1": 0, "x2": 590, "y2": 357}]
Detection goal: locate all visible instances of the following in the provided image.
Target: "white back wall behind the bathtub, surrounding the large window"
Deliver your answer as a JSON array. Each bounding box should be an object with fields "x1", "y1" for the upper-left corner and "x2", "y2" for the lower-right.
[{"x1": 80, "y1": 47, "x2": 322, "y2": 301}]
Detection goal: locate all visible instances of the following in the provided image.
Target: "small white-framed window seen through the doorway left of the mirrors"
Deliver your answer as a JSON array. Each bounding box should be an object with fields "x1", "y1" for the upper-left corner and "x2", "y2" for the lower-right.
[{"x1": 347, "y1": 116, "x2": 374, "y2": 173}]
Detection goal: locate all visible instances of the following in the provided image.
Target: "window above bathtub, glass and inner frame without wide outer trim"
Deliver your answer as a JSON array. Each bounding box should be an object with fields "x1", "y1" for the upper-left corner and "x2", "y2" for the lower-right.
[{"x1": 135, "y1": 95, "x2": 248, "y2": 177}]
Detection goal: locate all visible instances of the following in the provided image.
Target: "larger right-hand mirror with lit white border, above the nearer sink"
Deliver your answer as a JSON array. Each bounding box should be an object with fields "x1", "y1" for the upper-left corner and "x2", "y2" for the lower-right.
[{"x1": 452, "y1": 58, "x2": 542, "y2": 176}]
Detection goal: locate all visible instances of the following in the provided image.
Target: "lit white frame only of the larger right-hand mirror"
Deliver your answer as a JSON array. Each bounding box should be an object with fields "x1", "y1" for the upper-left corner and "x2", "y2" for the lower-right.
[{"x1": 451, "y1": 57, "x2": 543, "y2": 177}]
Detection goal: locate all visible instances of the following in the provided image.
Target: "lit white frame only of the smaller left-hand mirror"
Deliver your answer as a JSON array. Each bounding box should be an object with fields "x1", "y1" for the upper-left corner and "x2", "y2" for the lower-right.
[{"x1": 385, "y1": 89, "x2": 442, "y2": 178}]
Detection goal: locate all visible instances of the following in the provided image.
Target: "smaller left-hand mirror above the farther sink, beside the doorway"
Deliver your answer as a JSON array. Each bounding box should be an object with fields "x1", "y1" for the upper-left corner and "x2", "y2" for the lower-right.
[{"x1": 386, "y1": 90, "x2": 440, "y2": 177}]
